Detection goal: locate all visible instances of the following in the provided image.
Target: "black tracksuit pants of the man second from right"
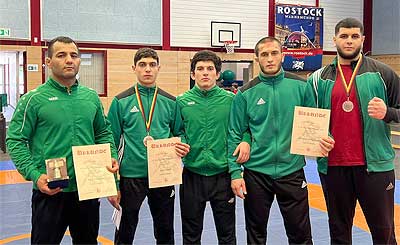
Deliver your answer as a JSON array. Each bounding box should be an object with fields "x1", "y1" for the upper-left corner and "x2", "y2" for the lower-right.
[{"x1": 243, "y1": 169, "x2": 312, "y2": 244}]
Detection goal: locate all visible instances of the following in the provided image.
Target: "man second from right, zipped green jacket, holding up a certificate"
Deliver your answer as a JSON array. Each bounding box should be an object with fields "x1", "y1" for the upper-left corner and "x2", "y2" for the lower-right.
[{"x1": 228, "y1": 37, "x2": 334, "y2": 244}]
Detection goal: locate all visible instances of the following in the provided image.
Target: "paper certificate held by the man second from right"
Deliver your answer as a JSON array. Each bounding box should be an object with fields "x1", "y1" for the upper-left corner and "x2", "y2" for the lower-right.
[{"x1": 290, "y1": 106, "x2": 331, "y2": 157}]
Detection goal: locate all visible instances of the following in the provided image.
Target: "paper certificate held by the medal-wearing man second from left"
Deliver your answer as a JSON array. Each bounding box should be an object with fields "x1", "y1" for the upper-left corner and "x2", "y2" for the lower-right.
[{"x1": 147, "y1": 137, "x2": 182, "y2": 188}]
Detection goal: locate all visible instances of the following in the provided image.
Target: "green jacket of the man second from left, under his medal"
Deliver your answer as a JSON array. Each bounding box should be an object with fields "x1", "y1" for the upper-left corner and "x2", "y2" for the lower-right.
[{"x1": 108, "y1": 84, "x2": 182, "y2": 178}]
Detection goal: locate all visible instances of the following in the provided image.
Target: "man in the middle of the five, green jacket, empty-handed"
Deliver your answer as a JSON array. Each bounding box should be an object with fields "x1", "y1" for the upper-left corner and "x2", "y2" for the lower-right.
[{"x1": 177, "y1": 50, "x2": 250, "y2": 244}]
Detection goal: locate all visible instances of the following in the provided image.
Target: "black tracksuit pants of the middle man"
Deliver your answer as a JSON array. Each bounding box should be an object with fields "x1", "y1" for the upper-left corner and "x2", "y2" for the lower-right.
[{"x1": 179, "y1": 168, "x2": 236, "y2": 245}]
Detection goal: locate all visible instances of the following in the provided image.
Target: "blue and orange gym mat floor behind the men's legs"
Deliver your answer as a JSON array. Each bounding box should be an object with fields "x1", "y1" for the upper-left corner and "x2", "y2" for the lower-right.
[{"x1": 0, "y1": 153, "x2": 400, "y2": 245}]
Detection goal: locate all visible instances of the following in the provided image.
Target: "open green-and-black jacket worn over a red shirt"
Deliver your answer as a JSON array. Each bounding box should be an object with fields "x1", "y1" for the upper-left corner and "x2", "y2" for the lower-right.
[{"x1": 306, "y1": 56, "x2": 400, "y2": 174}]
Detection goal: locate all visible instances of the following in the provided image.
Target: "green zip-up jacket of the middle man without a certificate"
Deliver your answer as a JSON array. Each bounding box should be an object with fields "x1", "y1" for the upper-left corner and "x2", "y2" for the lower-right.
[{"x1": 177, "y1": 86, "x2": 235, "y2": 176}]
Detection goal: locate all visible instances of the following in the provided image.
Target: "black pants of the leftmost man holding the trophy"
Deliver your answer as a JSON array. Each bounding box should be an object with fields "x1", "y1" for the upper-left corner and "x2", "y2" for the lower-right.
[{"x1": 31, "y1": 190, "x2": 100, "y2": 244}]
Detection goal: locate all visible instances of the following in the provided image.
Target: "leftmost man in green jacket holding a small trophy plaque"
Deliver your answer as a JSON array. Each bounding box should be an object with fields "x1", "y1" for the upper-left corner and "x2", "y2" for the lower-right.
[{"x1": 7, "y1": 37, "x2": 118, "y2": 244}]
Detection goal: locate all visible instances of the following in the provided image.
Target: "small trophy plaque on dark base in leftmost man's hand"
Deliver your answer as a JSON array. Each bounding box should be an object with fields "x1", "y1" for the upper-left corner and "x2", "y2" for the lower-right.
[{"x1": 46, "y1": 157, "x2": 69, "y2": 189}]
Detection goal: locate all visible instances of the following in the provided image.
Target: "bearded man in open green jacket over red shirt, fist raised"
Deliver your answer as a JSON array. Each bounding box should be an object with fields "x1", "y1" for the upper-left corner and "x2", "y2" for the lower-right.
[{"x1": 307, "y1": 18, "x2": 400, "y2": 244}]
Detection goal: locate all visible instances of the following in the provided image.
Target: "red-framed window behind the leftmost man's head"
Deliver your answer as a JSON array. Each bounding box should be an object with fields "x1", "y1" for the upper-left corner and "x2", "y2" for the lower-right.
[{"x1": 43, "y1": 49, "x2": 107, "y2": 97}]
